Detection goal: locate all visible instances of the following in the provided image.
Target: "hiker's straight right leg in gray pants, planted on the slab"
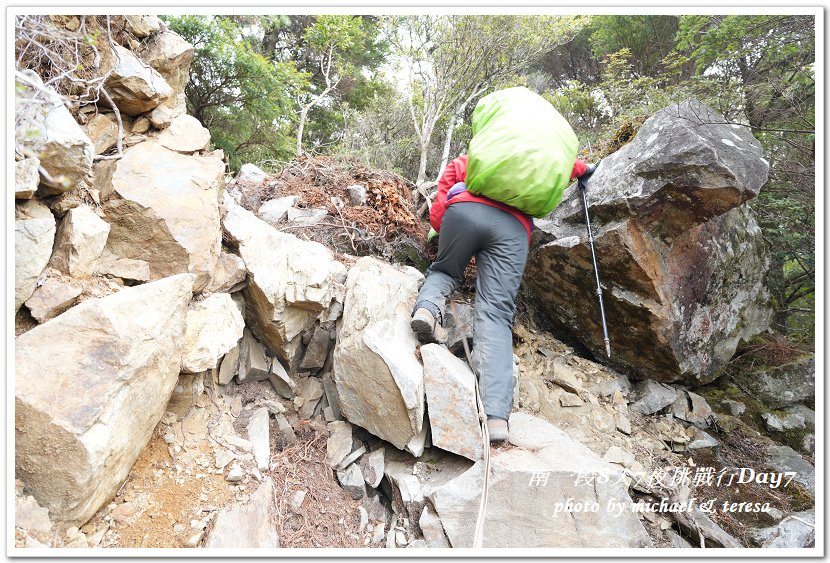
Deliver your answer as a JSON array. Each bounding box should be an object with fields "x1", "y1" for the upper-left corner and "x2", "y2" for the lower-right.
[{"x1": 472, "y1": 207, "x2": 528, "y2": 420}]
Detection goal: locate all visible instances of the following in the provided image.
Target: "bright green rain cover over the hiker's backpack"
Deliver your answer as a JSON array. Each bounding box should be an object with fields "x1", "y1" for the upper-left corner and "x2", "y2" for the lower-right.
[{"x1": 466, "y1": 87, "x2": 579, "y2": 217}]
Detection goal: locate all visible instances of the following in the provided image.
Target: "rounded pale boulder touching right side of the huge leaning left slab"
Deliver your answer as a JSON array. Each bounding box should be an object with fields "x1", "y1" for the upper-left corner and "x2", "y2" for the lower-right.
[{"x1": 182, "y1": 293, "x2": 245, "y2": 373}]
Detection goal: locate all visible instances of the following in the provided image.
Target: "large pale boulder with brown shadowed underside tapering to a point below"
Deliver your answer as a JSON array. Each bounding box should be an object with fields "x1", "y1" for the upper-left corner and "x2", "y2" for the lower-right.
[{"x1": 222, "y1": 196, "x2": 346, "y2": 367}]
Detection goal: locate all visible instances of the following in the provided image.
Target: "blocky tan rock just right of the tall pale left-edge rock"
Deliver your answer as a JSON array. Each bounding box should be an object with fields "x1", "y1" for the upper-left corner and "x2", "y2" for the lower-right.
[{"x1": 49, "y1": 205, "x2": 110, "y2": 279}]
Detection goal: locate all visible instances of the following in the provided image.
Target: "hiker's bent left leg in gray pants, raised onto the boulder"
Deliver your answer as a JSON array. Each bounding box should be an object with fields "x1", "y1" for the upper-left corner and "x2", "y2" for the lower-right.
[{"x1": 412, "y1": 202, "x2": 488, "y2": 337}]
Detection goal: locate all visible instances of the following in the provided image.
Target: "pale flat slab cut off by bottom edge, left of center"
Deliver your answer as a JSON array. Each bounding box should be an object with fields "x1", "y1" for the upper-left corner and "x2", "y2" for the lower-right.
[{"x1": 205, "y1": 477, "x2": 280, "y2": 549}]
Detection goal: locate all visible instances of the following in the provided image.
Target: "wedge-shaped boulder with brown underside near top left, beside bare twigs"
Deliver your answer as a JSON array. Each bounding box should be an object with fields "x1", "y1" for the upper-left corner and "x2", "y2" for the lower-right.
[{"x1": 104, "y1": 45, "x2": 173, "y2": 115}]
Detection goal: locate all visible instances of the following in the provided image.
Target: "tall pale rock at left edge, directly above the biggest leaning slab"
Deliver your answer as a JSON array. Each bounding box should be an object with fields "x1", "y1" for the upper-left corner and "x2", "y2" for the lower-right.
[{"x1": 14, "y1": 199, "x2": 55, "y2": 311}]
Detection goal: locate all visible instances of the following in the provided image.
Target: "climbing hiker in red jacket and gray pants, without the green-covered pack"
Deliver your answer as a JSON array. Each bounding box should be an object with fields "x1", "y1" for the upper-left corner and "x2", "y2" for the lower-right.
[{"x1": 411, "y1": 155, "x2": 587, "y2": 442}]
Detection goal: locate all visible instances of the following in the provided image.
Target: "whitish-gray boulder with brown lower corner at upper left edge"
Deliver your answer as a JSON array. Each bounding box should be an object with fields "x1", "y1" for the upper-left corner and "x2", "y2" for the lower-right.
[{"x1": 14, "y1": 70, "x2": 95, "y2": 196}]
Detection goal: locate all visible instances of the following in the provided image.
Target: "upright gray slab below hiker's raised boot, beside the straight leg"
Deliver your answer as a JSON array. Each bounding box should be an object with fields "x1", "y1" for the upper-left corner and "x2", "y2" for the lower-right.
[{"x1": 421, "y1": 344, "x2": 482, "y2": 461}]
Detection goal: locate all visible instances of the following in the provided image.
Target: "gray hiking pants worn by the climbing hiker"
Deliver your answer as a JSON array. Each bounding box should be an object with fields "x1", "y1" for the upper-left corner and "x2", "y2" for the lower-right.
[{"x1": 413, "y1": 201, "x2": 528, "y2": 419}]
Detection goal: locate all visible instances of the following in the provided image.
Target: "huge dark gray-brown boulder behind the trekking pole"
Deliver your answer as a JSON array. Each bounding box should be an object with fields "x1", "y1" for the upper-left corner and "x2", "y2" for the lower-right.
[{"x1": 526, "y1": 102, "x2": 771, "y2": 385}]
